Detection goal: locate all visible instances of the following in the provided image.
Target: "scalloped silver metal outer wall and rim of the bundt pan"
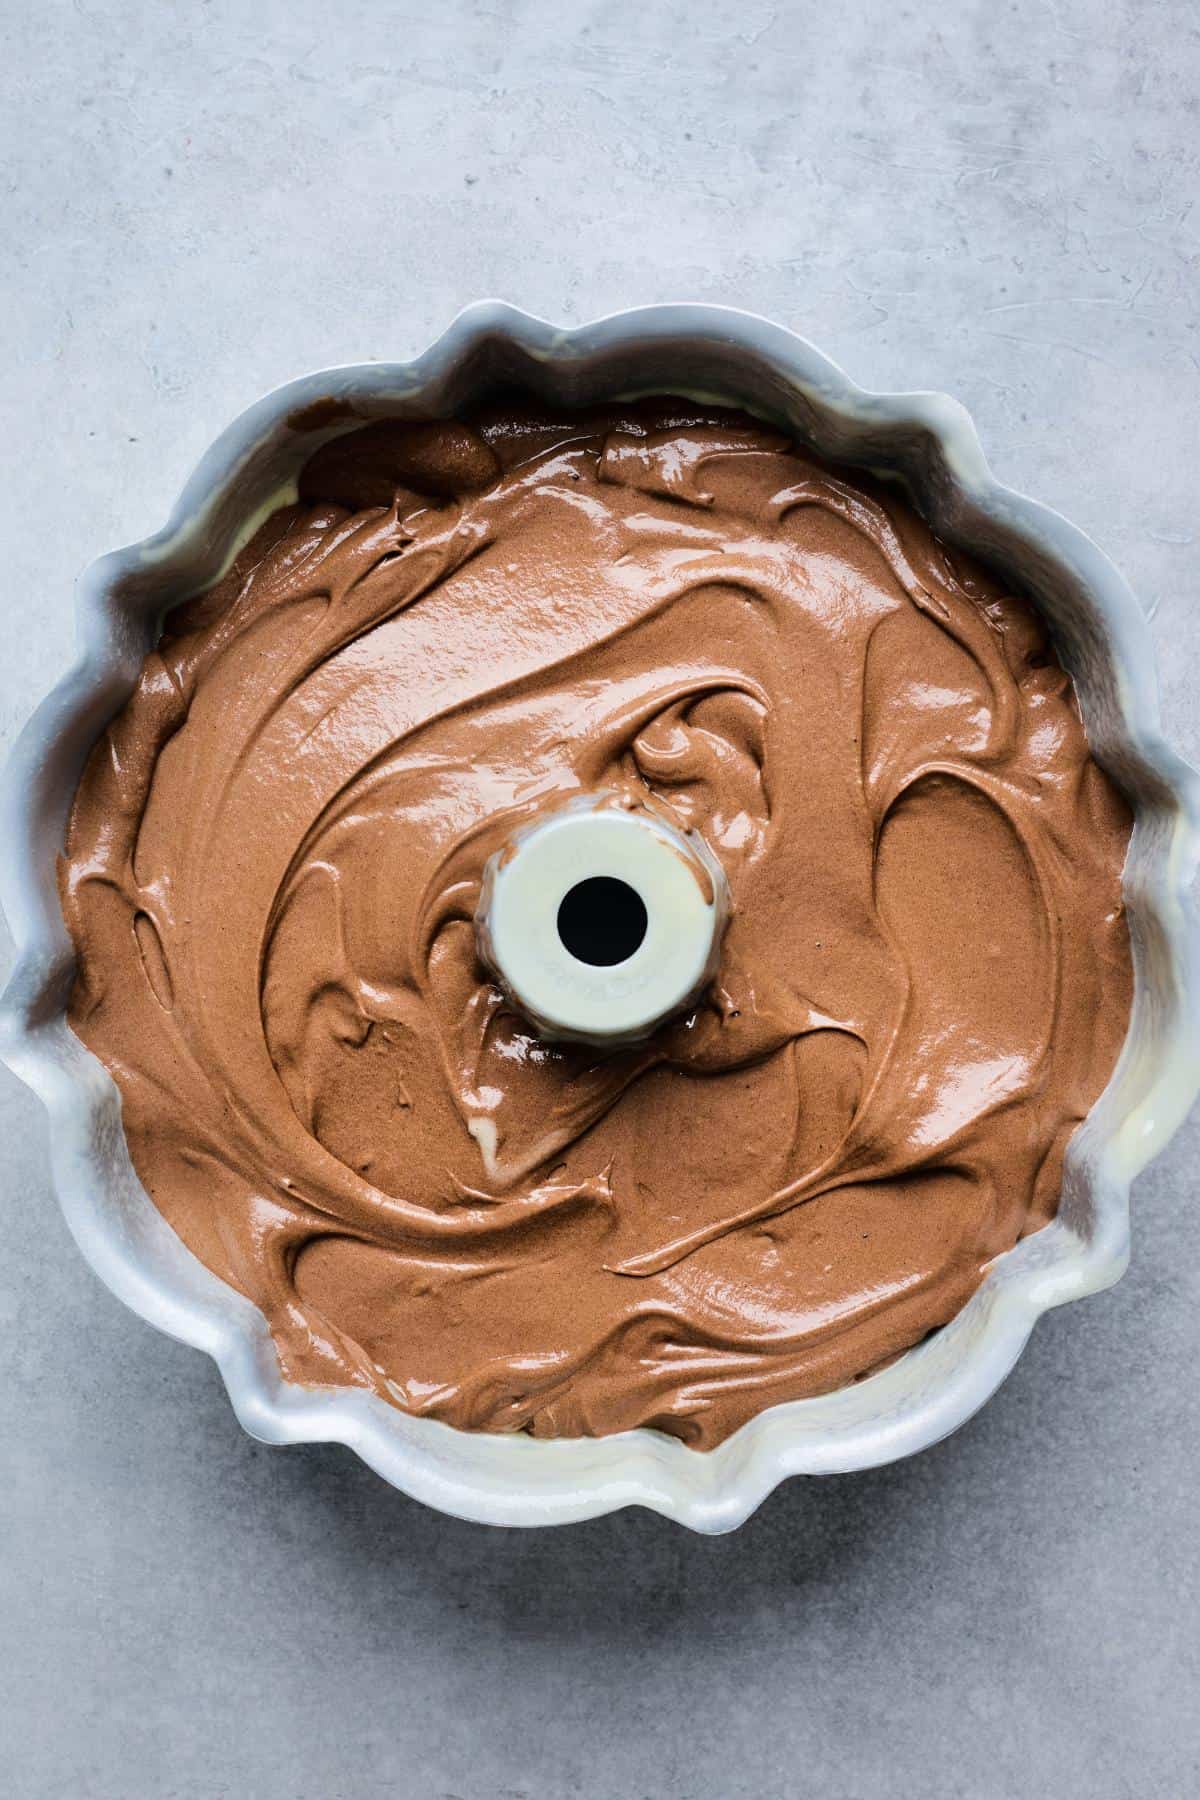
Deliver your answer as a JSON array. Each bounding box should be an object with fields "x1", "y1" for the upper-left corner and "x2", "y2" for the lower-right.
[{"x1": 0, "y1": 301, "x2": 1200, "y2": 1532}]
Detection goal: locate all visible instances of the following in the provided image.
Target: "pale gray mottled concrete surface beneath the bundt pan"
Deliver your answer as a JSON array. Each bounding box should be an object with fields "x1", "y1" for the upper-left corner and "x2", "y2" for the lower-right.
[{"x1": 0, "y1": 0, "x2": 1200, "y2": 1800}]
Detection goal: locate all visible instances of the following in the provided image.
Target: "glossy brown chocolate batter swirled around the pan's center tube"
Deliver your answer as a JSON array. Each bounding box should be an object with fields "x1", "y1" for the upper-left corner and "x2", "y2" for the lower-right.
[{"x1": 61, "y1": 401, "x2": 1130, "y2": 1447}]
